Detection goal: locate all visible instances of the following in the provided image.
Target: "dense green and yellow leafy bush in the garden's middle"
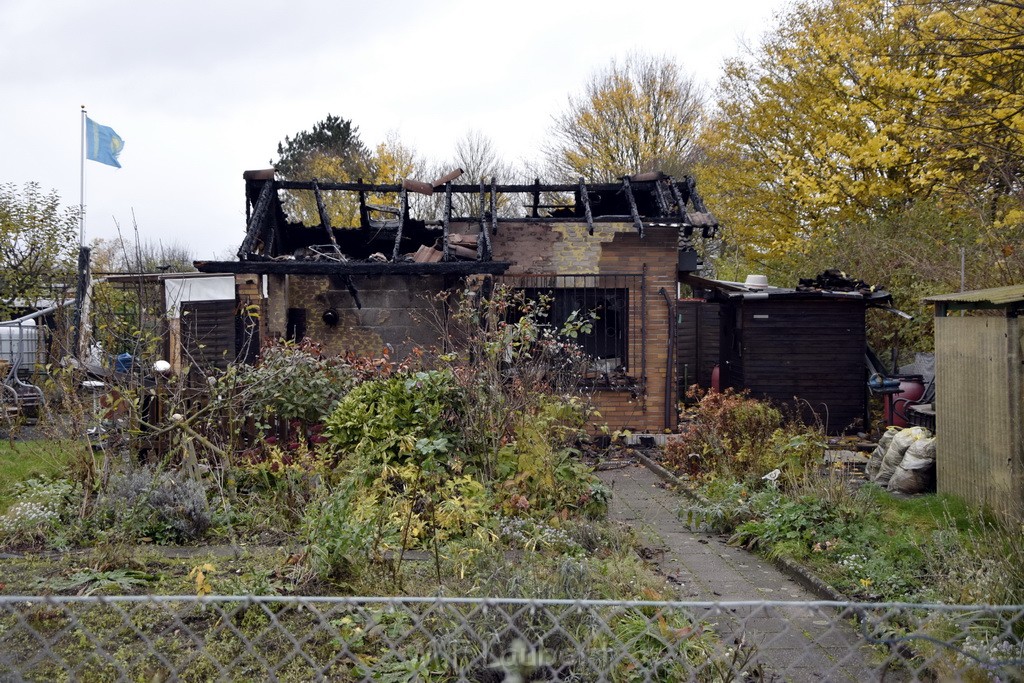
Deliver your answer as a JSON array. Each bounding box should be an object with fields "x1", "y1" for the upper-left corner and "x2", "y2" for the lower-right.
[{"x1": 303, "y1": 371, "x2": 490, "y2": 581}]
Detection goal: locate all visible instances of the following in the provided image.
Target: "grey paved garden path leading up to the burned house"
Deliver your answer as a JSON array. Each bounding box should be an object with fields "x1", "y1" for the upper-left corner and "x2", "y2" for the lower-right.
[{"x1": 598, "y1": 464, "x2": 883, "y2": 681}]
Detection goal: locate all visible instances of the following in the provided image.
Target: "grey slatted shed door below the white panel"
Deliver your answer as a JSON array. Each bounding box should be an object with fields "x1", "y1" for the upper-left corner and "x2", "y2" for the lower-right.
[{"x1": 181, "y1": 300, "x2": 236, "y2": 370}]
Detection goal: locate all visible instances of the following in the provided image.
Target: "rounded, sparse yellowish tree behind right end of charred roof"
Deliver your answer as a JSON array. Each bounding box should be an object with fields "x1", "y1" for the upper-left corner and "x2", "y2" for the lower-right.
[{"x1": 545, "y1": 54, "x2": 703, "y2": 181}]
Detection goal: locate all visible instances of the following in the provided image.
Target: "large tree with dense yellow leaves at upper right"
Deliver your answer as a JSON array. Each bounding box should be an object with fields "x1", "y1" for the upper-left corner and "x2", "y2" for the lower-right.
[{"x1": 701, "y1": 0, "x2": 1022, "y2": 285}]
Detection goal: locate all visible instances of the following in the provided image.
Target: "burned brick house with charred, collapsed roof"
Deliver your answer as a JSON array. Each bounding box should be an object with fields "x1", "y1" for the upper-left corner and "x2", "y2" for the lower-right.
[{"x1": 196, "y1": 170, "x2": 717, "y2": 432}]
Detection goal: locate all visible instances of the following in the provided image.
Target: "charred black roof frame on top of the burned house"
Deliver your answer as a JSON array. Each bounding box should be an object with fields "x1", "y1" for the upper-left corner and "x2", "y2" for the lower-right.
[{"x1": 204, "y1": 169, "x2": 718, "y2": 274}]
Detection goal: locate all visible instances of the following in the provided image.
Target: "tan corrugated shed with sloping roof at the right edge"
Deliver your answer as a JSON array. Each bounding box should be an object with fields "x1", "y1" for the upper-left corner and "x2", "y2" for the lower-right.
[{"x1": 925, "y1": 285, "x2": 1024, "y2": 519}]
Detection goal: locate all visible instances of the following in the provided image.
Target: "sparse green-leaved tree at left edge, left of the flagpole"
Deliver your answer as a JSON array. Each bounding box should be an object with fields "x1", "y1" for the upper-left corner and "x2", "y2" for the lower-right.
[{"x1": 0, "y1": 182, "x2": 79, "y2": 319}]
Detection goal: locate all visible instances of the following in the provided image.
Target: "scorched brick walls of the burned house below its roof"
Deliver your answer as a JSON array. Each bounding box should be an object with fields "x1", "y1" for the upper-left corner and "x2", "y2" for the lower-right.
[{"x1": 264, "y1": 221, "x2": 678, "y2": 432}]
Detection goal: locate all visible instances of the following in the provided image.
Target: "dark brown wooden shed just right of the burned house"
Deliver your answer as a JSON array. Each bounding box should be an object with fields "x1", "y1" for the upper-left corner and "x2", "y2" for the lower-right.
[{"x1": 687, "y1": 276, "x2": 891, "y2": 434}]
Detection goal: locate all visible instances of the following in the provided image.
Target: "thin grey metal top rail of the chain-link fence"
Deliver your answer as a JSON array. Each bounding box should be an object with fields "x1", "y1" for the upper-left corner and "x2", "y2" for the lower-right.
[{"x1": 0, "y1": 595, "x2": 1024, "y2": 612}]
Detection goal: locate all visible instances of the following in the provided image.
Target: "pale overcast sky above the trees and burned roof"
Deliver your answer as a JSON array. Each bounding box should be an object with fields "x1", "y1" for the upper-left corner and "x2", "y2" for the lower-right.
[{"x1": 0, "y1": 0, "x2": 785, "y2": 259}]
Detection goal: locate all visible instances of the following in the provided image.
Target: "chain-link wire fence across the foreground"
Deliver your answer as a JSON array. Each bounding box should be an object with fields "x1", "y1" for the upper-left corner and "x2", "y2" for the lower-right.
[{"x1": 0, "y1": 596, "x2": 1024, "y2": 682}]
